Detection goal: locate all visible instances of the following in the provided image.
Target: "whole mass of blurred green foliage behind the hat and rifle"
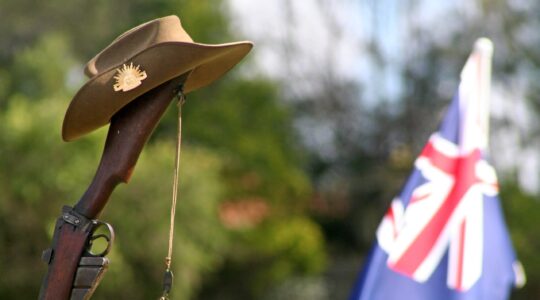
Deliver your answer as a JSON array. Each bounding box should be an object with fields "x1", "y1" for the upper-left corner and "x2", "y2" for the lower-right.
[{"x1": 0, "y1": 0, "x2": 325, "y2": 299}]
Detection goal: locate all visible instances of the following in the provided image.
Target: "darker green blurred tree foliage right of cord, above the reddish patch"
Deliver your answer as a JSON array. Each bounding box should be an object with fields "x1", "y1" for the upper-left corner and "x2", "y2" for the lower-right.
[{"x1": 181, "y1": 79, "x2": 309, "y2": 208}]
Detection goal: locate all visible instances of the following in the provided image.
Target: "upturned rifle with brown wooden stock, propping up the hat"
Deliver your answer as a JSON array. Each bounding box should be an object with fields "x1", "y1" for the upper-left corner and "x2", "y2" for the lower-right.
[{"x1": 39, "y1": 72, "x2": 189, "y2": 300}]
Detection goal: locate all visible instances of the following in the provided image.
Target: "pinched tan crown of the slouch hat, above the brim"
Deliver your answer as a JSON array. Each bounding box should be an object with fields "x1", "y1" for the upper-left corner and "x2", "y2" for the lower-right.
[{"x1": 84, "y1": 15, "x2": 193, "y2": 77}]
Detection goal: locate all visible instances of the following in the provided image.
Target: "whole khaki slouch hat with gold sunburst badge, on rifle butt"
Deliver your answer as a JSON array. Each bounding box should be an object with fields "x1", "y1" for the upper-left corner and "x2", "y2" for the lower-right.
[{"x1": 62, "y1": 16, "x2": 253, "y2": 141}]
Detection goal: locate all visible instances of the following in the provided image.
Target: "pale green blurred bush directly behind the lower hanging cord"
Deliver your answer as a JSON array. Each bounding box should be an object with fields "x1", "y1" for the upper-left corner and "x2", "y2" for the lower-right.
[{"x1": 96, "y1": 142, "x2": 228, "y2": 299}]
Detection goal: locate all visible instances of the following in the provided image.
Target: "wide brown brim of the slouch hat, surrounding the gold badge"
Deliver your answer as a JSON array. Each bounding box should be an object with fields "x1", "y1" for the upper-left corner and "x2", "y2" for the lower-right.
[{"x1": 62, "y1": 42, "x2": 253, "y2": 141}]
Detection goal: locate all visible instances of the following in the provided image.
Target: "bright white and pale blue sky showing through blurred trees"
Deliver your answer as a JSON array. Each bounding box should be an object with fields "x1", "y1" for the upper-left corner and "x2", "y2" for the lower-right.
[{"x1": 228, "y1": 0, "x2": 540, "y2": 192}]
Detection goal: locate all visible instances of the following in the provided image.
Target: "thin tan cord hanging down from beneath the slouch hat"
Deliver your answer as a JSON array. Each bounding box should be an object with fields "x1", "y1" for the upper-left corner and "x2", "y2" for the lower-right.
[{"x1": 159, "y1": 86, "x2": 186, "y2": 300}]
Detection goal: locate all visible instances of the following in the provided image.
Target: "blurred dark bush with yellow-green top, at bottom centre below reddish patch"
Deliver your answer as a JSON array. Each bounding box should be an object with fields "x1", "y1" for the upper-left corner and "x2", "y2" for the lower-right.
[{"x1": 201, "y1": 216, "x2": 326, "y2": 299}]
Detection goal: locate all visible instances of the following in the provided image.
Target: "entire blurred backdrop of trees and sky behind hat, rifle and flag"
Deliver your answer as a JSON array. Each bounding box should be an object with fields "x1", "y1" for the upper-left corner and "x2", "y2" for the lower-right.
[{"x1": 0, "y1": 0, "x2": 540, "y2": 300}]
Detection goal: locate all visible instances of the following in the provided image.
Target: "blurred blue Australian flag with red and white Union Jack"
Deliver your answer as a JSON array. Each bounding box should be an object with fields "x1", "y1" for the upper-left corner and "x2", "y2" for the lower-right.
[{"x1": 351, "y1": 39, "x2": 525, "y2": 300}]
